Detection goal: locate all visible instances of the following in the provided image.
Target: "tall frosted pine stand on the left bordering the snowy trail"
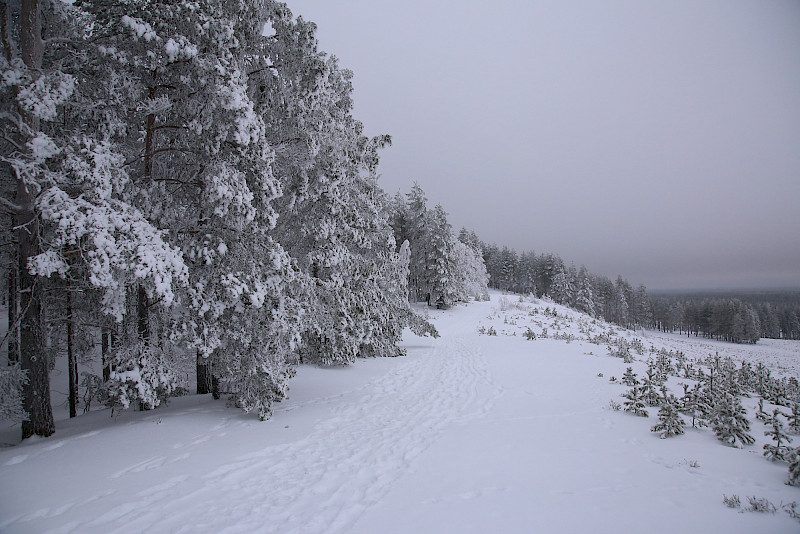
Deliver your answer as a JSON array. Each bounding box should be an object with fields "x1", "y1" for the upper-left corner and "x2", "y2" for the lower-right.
[{"x1": 0, "y1": 0, "x2": 486, "y2": 438}]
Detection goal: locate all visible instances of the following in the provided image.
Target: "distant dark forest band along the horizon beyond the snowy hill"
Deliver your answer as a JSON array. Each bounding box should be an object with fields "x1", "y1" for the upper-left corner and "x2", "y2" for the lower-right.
[{"x1": 459, "y1": 229, "x2": 800, "y2": 343}]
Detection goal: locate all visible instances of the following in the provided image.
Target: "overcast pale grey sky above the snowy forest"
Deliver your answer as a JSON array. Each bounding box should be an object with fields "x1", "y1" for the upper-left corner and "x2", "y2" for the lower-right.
[{"x1": 288, "y1": 0, "x2": 800, "y2": 289}]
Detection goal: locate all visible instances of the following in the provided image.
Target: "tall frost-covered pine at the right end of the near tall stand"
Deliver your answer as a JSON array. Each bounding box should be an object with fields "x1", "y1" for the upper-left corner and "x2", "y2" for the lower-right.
[{"x1": 257, "y1": 15, "x2": 434, "y2": 370}]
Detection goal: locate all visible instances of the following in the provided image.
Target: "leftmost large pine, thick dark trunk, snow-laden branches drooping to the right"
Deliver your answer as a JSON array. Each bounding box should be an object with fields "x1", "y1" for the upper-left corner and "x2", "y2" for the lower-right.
[{"x1": 0, "y1": 2, "x2": 203, "y2": 436}]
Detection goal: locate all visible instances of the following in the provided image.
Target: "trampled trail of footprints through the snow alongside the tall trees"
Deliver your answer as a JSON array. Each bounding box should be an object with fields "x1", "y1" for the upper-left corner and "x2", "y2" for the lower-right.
[{"x1": 75, "y1": 338, "x2": 501, "y2": 534}]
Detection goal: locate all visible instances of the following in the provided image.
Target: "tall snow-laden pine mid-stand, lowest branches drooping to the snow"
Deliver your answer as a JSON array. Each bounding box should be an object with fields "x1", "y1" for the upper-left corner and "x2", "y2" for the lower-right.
[{"x1": 68, "y1": 1, "x2": 310, "y2": 415}]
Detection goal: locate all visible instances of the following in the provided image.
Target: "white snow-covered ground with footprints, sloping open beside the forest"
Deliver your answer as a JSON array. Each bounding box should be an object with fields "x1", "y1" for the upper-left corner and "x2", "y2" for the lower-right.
[{"x1": 0, "y1": 294, "x2": 800, "y2": 534}]
